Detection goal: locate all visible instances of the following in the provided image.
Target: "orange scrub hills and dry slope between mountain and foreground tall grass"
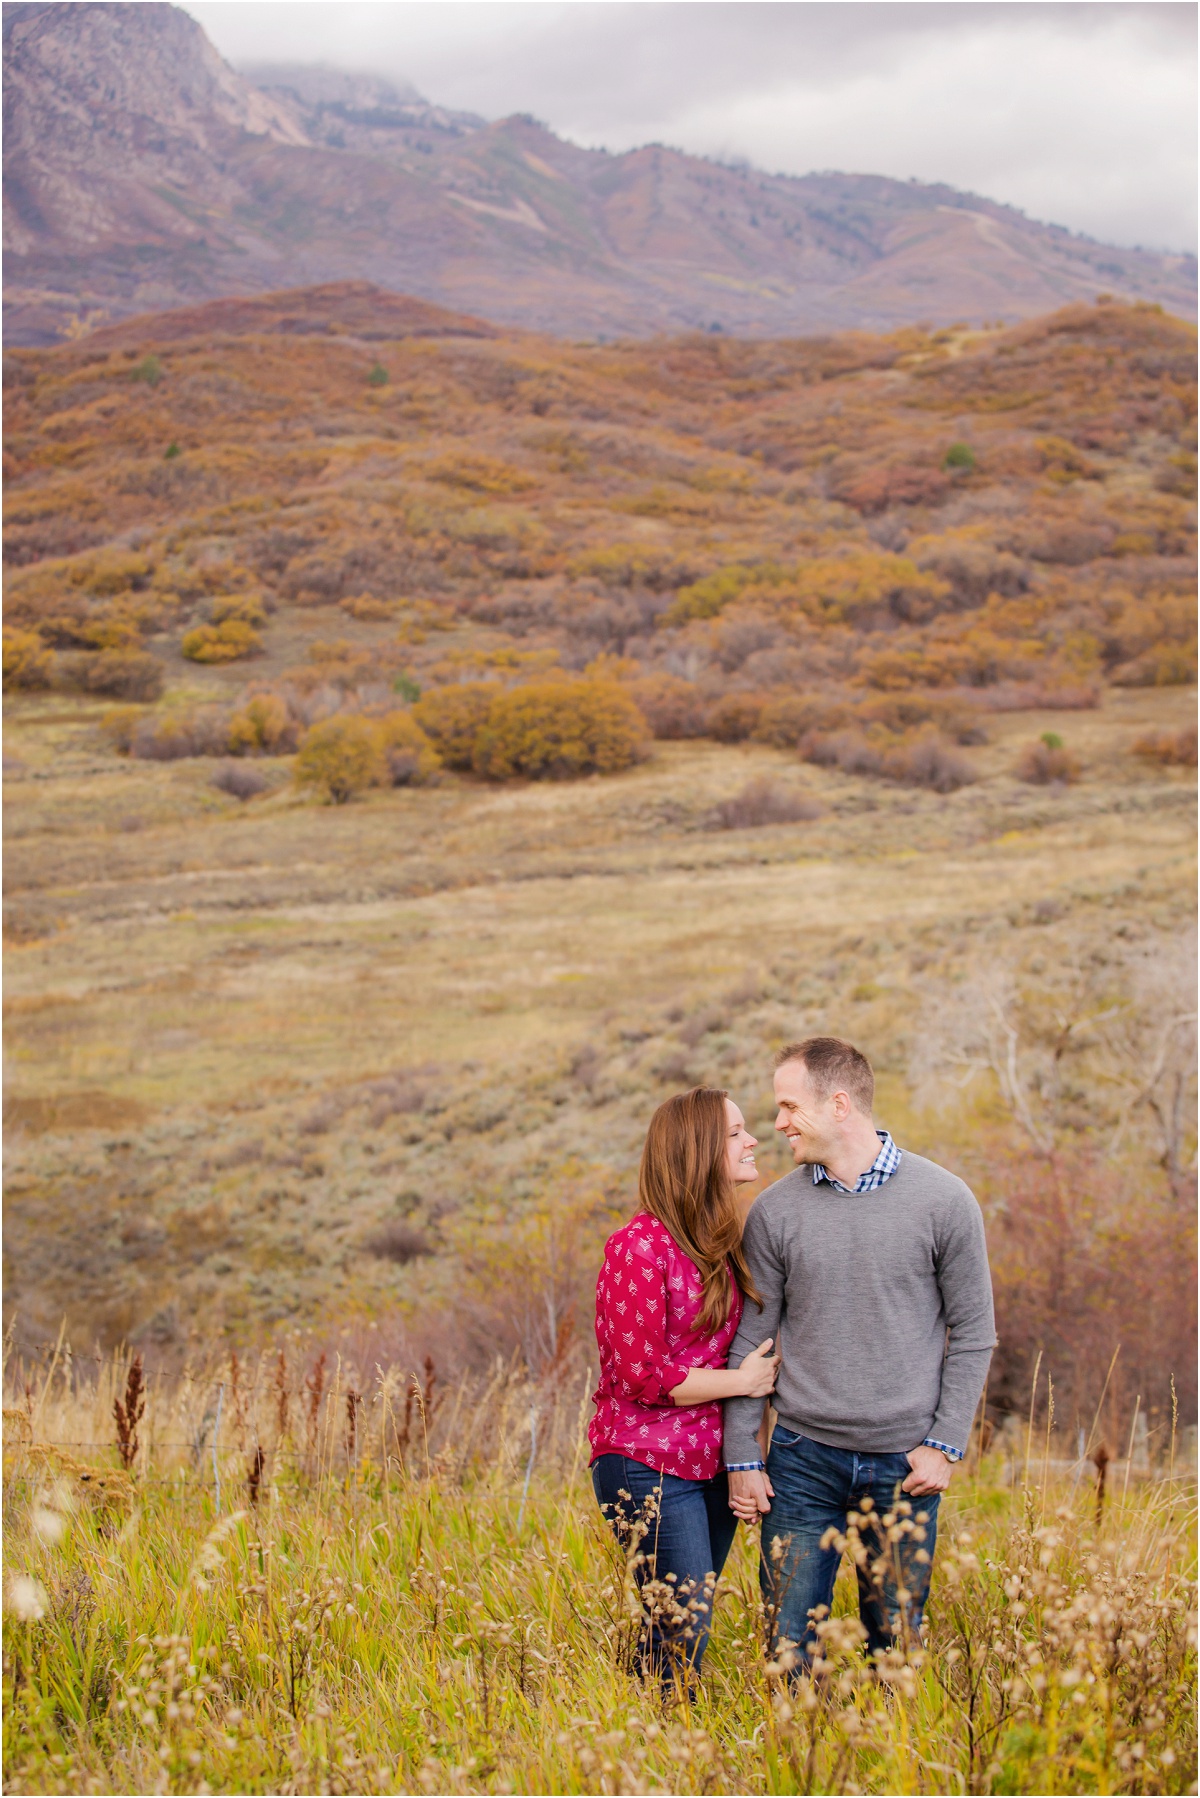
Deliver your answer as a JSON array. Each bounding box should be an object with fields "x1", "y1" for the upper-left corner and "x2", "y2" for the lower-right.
[{"x1": 5, "y1": 286, "x2": 1195, "y2": 1429}]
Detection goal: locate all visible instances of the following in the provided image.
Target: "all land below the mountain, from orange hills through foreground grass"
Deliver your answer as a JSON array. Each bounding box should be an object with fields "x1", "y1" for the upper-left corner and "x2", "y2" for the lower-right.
[{"x1": 4, "y1": 288, "x2": 1196, "y2": 1793}]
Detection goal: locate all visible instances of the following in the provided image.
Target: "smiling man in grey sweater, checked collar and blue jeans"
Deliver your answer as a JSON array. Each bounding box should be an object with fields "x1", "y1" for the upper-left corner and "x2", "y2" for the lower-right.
[{"x1": 725, "y1": 1036, "x2": 995, "y2": 1665}]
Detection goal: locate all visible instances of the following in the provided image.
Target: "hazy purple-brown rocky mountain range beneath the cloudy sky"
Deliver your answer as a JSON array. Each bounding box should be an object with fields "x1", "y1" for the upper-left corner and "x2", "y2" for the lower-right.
[{"x1": 4, "y1": 4, "x2": 1196, "y2": 343}]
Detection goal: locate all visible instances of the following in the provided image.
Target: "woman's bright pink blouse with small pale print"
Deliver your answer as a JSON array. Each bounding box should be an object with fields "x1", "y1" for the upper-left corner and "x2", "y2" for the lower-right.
[{"x1": 588, "y1": 1212, "x2": 741, "y2": 1480}]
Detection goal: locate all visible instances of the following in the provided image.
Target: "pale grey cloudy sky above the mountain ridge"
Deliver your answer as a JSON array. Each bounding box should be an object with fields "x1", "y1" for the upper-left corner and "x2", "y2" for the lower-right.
[{"x1": 185, "y1": 0, "x2": 1196, "y2": 250}]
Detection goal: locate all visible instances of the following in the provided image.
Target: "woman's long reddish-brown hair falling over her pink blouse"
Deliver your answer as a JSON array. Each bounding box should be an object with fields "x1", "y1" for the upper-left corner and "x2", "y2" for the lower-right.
[{"x1": 637, "y1": 1086, "x2": 763, "y2": 1331}]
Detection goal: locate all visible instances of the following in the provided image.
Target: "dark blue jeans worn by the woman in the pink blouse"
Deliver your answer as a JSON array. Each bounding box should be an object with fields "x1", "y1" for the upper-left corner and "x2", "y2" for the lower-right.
[{"x1": 592, "y1": 1455, "x2": 738, "y2": 1690}]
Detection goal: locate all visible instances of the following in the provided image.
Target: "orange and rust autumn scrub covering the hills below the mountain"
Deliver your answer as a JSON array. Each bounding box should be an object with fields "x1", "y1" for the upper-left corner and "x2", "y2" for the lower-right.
[{"x1": 4, "y1": 302, "x2": 1196, "y2": 788}]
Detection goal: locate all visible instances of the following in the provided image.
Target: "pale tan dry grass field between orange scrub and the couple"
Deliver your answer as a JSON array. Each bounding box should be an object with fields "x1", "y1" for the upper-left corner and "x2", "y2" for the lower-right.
[{"x1": 5, "y1": 689, "x2": 1193, "y2": 1380}]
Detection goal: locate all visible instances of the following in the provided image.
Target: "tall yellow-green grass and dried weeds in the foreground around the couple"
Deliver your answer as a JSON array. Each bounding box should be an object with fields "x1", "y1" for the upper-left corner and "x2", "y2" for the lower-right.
[{"x1": 4, "y1": 1345, "x2": 1196, "y2": 1793}]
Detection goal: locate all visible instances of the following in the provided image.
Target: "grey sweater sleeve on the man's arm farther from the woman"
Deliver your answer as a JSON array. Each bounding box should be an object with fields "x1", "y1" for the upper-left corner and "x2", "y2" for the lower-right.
[{"x1": 928, "y1": 1187, "x2": 997, "y2": 1451}]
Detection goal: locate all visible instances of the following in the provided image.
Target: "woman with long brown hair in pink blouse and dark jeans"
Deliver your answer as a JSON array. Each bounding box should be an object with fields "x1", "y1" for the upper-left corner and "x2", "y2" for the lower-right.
[{"x1": 588, "y1": 1086, "x2": 779, "y2": 1688}]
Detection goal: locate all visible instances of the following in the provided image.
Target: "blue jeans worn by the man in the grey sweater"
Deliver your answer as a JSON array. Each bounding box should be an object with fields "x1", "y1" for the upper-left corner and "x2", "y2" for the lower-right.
[{"x1": 759, "y1": 1426, "x2": 941, "y2": 1667}]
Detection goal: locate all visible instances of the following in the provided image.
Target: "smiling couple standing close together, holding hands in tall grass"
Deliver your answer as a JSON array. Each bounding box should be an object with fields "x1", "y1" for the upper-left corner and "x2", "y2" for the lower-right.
[{"x1": 588, "y1": 1036, "x2": 995, "y2": 1688}]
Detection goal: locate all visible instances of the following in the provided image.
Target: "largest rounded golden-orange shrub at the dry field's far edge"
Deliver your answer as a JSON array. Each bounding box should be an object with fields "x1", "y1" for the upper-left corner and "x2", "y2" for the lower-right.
[{"x1": 473, "y1": 680, "x2": 646, "y2": 780}]
